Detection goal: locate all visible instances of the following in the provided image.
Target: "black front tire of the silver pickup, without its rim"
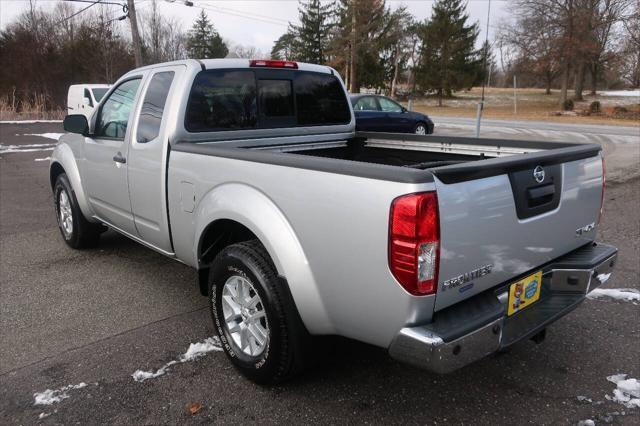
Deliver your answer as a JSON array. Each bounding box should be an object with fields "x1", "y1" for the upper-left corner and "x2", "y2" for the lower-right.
[{"x1": 53, "y1": 173, "x2": 103, "y2": 249}]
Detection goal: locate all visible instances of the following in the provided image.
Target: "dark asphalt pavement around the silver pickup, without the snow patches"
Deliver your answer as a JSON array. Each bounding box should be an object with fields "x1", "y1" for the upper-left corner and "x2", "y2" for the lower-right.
[{"x1": 0, "y1": 124, "x2": 640, "y2": 425}]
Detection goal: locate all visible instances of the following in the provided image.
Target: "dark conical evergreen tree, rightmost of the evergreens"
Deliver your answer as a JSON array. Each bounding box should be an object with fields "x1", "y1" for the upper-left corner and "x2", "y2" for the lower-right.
[{"x1": 416, "y1": 0, "x2": 483, "y2": 106}]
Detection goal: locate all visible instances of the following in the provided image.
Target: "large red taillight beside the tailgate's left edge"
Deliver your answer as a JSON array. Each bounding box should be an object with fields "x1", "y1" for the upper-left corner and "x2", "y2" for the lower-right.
[{"x1": 389, "y1": 192, "x2": 440, "y2": 296}]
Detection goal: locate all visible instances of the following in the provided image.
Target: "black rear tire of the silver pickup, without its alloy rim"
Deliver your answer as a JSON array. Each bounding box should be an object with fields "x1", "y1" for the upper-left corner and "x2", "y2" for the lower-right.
[{"x1": 209, "y1": 240, "x2": 310, "y2": 385}]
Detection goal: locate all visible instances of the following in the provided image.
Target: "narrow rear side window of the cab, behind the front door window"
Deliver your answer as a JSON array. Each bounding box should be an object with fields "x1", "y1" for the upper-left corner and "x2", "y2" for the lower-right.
[{"x1": 136, "y1": 71, "x2": 175, "y2": 143}]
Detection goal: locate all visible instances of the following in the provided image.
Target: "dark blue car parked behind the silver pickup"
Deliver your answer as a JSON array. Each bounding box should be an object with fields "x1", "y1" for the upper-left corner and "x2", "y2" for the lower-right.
[{"x1": 350, "y1": 94, "x2": 434, "y2": 135}]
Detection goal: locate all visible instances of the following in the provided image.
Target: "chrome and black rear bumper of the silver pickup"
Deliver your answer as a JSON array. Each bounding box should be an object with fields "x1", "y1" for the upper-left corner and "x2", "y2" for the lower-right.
[{"x1": 389, "y1": 243, "x2": 618, "y2": 373}]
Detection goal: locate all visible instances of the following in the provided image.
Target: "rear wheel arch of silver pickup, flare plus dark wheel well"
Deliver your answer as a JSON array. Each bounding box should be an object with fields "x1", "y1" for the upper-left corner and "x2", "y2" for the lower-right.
[{"x1": 194, "y1": 183, "x2": 333, "y2": 334}]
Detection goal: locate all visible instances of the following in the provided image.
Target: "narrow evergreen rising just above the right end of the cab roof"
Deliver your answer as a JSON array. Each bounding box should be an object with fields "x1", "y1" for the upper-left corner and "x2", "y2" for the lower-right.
[{"x1": 290, "y1": 0, "x2": 333, "y2": 64}]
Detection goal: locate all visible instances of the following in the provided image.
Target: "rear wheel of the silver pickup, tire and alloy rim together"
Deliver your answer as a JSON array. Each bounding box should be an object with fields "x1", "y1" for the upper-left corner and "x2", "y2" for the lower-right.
[{"x1": 209, "y1": 240, "x2": 308, "y2": 384}]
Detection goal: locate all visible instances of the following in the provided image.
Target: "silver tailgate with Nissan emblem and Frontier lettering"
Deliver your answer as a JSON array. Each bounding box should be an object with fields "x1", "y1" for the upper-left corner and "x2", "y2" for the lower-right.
[{"x1": 433, "y1": 145, "x2": 603, "y2": 310}]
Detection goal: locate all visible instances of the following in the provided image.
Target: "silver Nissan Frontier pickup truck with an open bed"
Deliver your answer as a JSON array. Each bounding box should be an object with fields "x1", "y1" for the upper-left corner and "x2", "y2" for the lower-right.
[{"x1": 50, "y1": 59, "x2": 617, "y2": 383}]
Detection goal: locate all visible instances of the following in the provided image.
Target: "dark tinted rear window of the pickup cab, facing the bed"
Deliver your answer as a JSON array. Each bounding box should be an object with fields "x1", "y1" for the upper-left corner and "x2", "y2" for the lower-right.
[{"x1": 185, "y1": 70, "x2": 351, "y2": 132}]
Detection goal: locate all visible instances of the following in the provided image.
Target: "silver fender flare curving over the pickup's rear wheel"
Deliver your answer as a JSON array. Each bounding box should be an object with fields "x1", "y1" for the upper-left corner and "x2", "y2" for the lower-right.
[{"x1": 193, "y1": 183, "x2": 333, "y2": 334}]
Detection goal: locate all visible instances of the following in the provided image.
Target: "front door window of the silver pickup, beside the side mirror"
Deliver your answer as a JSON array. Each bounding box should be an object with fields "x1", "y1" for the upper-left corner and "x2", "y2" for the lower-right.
[{"x1": 95, "y1": 78, "x2": 141, "y2": 140}]
